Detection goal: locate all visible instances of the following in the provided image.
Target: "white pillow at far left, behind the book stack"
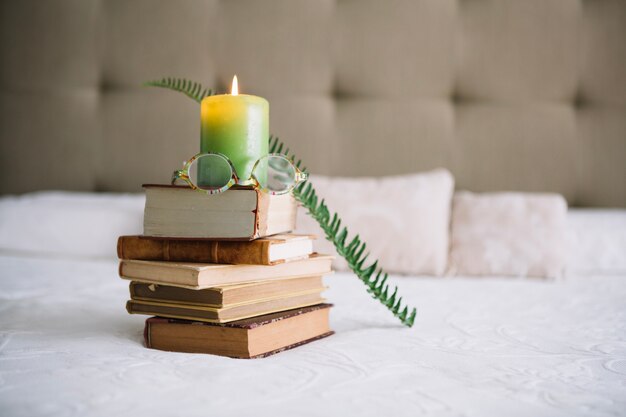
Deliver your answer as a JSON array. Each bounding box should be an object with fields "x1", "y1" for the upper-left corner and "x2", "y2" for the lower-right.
[{"x1": 0, "y1": 191, "x2": 145, "y2": 257}]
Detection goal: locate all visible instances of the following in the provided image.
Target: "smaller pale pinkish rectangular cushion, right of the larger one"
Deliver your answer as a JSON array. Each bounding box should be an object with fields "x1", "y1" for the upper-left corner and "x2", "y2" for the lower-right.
[{"x1": 449, "y1": 192, "x2": 567, "y2": 277}]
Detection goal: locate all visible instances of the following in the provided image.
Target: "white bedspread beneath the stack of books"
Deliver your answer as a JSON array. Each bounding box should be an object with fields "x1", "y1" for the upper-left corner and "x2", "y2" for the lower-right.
[{"x1": 0, "y1": 254, "x2": 626, "y2": 417}]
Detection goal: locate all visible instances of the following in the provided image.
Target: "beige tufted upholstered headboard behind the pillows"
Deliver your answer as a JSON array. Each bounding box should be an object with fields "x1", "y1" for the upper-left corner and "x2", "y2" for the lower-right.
[{"x1": 0, "y1": 0, "x2": 626, "y2": 206}]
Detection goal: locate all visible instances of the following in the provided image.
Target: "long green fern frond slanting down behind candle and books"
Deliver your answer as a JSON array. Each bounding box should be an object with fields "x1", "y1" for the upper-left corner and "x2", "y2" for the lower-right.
[{"x1": 144, "y1": 78, "x2": 417, "y2": 327}]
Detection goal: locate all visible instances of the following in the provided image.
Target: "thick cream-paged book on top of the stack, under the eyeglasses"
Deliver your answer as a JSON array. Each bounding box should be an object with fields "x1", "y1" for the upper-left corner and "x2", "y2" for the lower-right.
[{"x1": 143, "y1": 184, "x2": 297, "y2": 240}]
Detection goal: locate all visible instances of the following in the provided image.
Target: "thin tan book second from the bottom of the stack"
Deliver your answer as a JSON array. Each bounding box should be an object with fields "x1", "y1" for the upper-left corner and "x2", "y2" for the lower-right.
[{"x1": 126, "y1": 288, "x2": 324, "y2": 323}]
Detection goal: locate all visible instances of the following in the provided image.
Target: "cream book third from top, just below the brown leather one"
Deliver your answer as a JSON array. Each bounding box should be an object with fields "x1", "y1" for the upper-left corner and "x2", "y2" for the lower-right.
[{"x1": 119, "y1": 254, "x2": 333, "y2": 289}]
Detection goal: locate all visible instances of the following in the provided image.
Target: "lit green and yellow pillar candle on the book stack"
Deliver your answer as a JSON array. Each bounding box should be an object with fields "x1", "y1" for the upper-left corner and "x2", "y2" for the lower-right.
[{"x1": 200, "y1": 76, "x2": 269, "y2": 185}]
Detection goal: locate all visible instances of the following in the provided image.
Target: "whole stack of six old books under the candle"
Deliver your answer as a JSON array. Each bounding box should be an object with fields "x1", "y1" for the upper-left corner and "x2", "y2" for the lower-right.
[{"x1": 117, "y1": 185, "x2": 333, "y2": 358}]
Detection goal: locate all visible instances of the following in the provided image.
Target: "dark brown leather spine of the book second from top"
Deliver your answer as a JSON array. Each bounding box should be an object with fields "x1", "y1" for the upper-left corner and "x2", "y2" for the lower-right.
[{"x1": 117, "y1": 236, "x2": 271, "y2": 265}]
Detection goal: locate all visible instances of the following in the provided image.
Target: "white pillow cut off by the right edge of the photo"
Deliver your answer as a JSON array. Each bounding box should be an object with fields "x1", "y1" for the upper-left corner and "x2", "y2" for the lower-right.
[{"x1": 567, "y1": 209, "x2": 626, "y2": 275}]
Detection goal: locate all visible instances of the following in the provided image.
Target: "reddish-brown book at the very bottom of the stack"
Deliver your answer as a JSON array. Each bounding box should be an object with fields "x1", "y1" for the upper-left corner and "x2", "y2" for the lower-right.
[{"x1": 144, "y1": 304, "x2": 334, "y2": 359}]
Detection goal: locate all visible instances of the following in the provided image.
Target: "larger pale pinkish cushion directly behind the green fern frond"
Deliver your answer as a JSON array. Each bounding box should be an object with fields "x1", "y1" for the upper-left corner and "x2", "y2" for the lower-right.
[{"x1": 297, "y1": 169, "x2": 454, "y2": 275}]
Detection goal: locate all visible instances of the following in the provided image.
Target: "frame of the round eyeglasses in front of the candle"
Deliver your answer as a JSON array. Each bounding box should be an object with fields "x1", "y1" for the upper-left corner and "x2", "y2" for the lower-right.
[{"x1": 172, "y1": 152, "x2": 309, "y2": 195}]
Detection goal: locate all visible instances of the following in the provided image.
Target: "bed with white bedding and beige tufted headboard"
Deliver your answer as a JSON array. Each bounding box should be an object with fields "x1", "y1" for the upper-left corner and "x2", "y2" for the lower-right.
[{"x1": 0, "y1": 0, "x2": 626, "y2": 417}]
